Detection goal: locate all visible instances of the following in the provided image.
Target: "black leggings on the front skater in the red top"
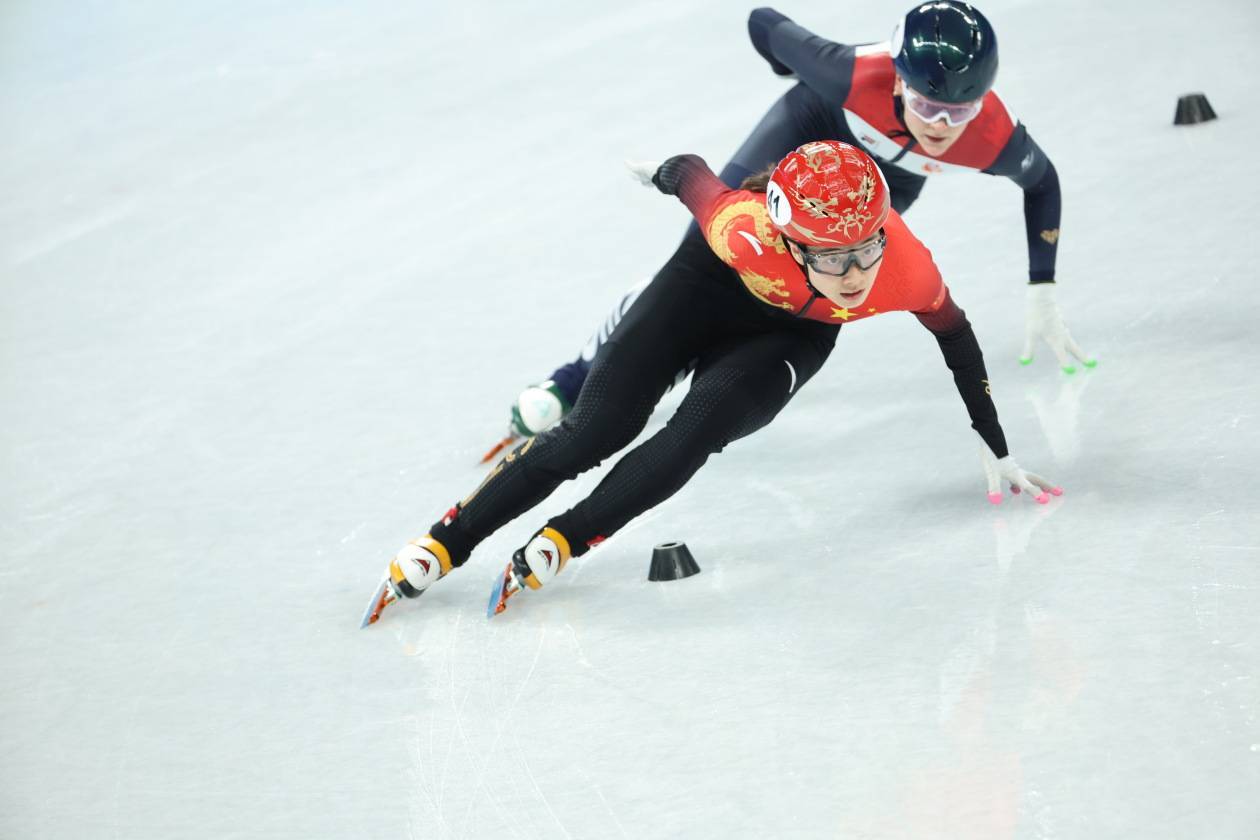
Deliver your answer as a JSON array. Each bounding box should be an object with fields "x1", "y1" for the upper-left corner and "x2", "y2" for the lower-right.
[{"x1": 431, "y1": 233, "x2": 839, "y2": 565}]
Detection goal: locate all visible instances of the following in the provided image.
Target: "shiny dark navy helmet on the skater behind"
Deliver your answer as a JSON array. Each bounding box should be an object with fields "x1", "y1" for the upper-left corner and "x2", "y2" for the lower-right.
[{"x1": 892, "y1": 0, "x2": 998, "y2": 102}]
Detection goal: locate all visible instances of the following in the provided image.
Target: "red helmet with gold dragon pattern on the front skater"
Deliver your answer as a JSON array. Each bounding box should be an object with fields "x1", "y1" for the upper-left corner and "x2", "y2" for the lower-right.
[{"x1": 766, "y1": 140, "x2": 888, "y2": 248}]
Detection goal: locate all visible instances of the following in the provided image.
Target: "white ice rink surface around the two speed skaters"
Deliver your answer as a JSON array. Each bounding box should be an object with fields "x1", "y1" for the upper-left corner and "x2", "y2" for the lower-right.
[{"x1": 0, "y1": 0, "x2": 1260, "y2": 840}]
